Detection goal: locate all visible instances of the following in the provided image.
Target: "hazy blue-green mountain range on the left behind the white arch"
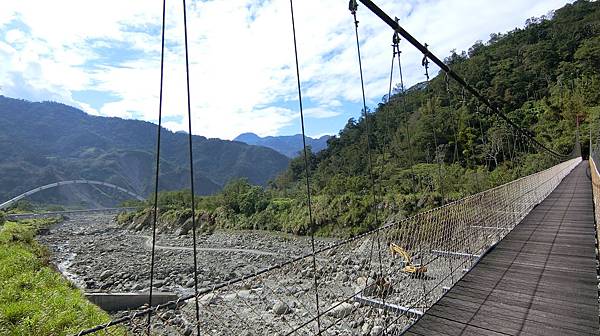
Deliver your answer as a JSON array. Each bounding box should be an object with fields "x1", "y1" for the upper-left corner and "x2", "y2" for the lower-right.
[{"x1": 0, "y1": 96, "x2": 289, "y2": 207}]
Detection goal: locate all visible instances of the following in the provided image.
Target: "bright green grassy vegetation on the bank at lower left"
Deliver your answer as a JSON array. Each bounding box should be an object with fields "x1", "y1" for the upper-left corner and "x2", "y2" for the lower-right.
[{"x1": 0, "y1": 219, "x2": 117, "y2": 336}]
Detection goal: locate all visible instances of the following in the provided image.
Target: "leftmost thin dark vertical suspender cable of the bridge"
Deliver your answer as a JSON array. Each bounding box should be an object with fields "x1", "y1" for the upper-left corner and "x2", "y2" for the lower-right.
[{"x1": 147, "y1": 0, "x2": 167, "y2": 335}]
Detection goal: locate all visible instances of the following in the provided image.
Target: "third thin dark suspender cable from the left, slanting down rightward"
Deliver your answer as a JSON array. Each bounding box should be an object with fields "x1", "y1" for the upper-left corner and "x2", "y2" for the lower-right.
[{"x1": 290, "y1": 0, "x2": 321, "y2": 335}]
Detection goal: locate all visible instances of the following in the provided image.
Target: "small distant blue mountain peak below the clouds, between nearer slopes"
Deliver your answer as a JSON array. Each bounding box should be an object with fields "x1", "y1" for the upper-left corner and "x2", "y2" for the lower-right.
[{"x1": 233, "y1": 133, "x2": 330, "y2": 158}]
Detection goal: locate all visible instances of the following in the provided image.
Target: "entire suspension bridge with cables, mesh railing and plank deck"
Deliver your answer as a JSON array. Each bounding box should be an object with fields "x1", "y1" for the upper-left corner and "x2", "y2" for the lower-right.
[{"x1": 22, "y1": 0, "x2": 600, "y2": 335}]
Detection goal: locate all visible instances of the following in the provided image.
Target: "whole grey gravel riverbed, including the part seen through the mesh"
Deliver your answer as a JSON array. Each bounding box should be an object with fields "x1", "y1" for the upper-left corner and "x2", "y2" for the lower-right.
[{"x1": 39, "y1": 214, "x2": 465, "y2": 335}]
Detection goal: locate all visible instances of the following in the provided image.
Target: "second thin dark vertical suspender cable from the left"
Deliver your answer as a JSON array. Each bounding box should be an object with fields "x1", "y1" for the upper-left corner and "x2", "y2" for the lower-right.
[{"x1": 183, "y1": 0, "x2": 200, "y2": 336}]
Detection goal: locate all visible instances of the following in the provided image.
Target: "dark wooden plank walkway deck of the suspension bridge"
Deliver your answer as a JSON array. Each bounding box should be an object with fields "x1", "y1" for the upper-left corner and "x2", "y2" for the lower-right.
[{"x1": 404, "y1": 161, "x2": 600, "y2": 336}]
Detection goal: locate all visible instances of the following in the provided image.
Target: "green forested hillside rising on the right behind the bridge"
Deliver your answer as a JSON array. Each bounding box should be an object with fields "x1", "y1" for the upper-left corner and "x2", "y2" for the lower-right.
[{"x1": 120, "y1": 0, "x2": 600, "y2": 235}]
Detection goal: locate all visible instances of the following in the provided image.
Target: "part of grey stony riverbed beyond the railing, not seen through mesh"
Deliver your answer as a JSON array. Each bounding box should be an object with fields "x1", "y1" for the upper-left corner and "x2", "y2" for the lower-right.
[{"x1": 39, "y1": 214, "x2": 332, "y2": 294}]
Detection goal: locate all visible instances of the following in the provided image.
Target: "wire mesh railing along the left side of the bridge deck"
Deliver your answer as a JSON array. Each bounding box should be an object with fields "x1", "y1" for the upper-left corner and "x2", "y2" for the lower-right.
[{"x1": 79, "y1": 158, "x2": 580, "y2": 335}]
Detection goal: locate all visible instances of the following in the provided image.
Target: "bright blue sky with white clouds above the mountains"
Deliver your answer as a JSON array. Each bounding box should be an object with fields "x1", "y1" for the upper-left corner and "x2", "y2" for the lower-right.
[{"x1": 0, "y1": 0, "x2": 571, "y2": 139}]
